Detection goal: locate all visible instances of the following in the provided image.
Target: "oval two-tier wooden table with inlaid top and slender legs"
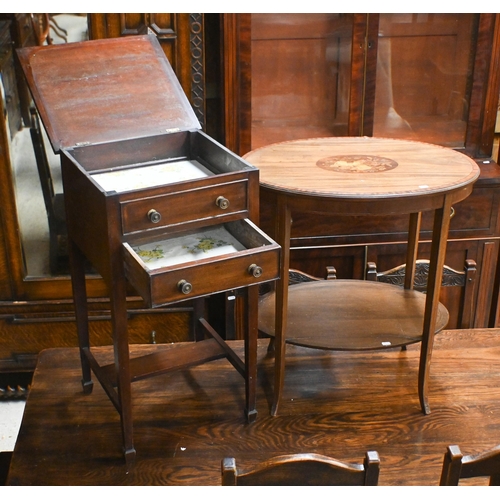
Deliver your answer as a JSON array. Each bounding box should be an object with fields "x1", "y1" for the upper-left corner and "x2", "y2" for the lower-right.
[{"x1": 244, "y1": 137, "x2": 479, "y2": 415}]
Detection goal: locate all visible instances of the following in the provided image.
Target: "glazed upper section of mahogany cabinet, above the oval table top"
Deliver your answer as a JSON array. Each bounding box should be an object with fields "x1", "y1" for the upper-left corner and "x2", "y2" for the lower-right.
[{"x1": 223, "y1": 14, "x2": 499, "y2": 156}]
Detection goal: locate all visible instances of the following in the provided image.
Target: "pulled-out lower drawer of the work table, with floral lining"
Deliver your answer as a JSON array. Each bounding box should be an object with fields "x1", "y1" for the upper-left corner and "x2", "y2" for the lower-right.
[{"x1": 123, "y1": 219, "x2": 280, "y2": 307}]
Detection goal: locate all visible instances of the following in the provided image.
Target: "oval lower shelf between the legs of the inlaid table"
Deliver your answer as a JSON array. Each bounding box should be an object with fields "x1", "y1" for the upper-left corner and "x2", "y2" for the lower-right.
[{"x1": 259, "y1": 280, "x2": 449, "y2": 351}]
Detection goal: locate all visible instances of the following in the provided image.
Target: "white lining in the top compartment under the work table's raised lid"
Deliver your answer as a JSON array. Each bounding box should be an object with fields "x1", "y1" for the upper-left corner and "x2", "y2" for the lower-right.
[{"x1": 92, "y1": 160, "x2": 214, "y2": 193}]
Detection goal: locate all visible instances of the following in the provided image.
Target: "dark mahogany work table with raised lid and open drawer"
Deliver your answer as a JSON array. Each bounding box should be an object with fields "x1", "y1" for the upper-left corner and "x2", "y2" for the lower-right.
[{"x1": 19, "y1": 35, "x2": 280, "y2": 464}]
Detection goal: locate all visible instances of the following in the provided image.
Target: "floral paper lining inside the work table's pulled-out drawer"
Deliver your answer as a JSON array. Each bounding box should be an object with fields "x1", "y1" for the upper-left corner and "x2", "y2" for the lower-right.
[{"x1": 132, "y1": 226, "x2": 246, "y2": 270}]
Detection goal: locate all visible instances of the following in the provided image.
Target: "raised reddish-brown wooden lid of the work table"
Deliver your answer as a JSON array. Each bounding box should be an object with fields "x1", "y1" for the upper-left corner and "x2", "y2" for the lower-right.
[{"x1": 18, "y1": 35, "x2": 201, "y2": 153}]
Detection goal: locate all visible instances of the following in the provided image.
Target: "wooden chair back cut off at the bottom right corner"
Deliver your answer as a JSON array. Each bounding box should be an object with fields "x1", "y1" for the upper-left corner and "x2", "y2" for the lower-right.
[{"x1": 439, "y1": 445, "x2": 500, "y2": 486}]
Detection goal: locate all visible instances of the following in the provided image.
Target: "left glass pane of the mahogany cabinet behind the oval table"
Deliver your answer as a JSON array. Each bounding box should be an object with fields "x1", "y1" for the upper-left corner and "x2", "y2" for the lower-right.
[{"x1": 251, "y1": 13, "x2": 353, "y2": 149}]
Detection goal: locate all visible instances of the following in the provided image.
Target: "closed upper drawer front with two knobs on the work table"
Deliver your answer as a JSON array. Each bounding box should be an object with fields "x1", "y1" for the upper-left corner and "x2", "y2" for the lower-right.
[{"x1": 121, "y1": 179, "x2": 248, "y2": 234}]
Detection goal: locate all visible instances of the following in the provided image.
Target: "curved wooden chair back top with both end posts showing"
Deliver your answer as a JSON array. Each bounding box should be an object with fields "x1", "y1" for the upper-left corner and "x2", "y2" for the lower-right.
[{"x1": 221, "y1": 451, "x2": 380, "y2": 486}]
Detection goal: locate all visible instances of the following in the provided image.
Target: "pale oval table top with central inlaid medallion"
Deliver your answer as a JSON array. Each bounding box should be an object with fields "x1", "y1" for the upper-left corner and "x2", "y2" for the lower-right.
[{"x1": 244, "y1": 137, "x2": 480, "y2": 200}]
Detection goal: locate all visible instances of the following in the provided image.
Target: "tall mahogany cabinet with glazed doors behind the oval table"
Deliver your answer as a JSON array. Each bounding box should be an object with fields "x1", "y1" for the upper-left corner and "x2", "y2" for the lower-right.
[{"x1": 221, "y1": 13, "x2": 500, "y2": 327}]
